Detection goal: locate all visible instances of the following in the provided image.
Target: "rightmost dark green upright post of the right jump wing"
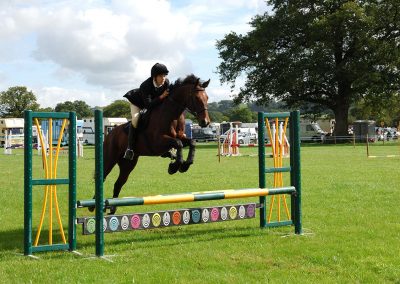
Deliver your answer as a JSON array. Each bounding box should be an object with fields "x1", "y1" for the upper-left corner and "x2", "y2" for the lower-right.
[{"x1": 290, "y1": 111, "x2": 303, "y2": 234}]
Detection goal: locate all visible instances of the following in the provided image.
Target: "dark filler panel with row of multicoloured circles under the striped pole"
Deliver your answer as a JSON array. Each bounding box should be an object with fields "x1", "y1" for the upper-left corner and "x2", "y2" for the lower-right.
[{"x1": 78, "y1": 203, "x2": 256, "y2": 235}]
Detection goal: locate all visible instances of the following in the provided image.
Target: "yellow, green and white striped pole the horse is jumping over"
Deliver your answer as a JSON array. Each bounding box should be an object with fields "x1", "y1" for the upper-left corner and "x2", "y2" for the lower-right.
[{"x1": 105, "y1": 186, "x2": 296, "y2": 206}]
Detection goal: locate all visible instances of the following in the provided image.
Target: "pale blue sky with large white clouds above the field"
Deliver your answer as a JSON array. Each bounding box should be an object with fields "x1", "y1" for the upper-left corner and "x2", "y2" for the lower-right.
[{"x1": 0, "y1": 0, "x2": 268, "y2": 107}]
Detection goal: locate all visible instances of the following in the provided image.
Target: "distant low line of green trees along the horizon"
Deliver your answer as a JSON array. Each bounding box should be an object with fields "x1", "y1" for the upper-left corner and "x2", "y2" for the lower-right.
[{"x1": 0, "y1": 86, "x2": 400, "y2": 126}]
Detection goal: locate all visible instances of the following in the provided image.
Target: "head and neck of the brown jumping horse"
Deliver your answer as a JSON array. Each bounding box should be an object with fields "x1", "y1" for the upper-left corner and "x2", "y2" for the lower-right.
[{"x1": 170, "y1": 75, "x2": 210, "y2": 127}]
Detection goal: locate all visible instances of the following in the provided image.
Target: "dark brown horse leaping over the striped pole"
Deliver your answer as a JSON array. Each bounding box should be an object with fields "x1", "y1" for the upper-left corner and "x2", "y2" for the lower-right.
[{"x1": 89, "y1": 74, "x2": 210, "y2": 214}]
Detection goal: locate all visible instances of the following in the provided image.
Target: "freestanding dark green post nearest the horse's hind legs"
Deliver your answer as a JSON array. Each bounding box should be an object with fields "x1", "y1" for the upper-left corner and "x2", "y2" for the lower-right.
[{"x1": 94, "y1": 109, "x2": 104, "y2": 256}]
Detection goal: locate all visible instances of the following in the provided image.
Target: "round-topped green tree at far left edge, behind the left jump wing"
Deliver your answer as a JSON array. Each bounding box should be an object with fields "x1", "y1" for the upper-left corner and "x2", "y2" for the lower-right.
[{"x1": 0, "y1": 86, "x2": 39, "y2": 117}]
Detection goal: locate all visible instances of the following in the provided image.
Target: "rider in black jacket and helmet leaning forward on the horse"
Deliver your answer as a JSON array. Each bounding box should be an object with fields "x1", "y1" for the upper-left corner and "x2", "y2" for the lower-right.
[{"x1": 124, "y1": 63, "x2": 169, "y2": 160}]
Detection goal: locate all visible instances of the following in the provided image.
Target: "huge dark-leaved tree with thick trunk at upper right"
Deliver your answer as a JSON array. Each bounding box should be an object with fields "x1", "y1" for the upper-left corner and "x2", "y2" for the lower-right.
[{"x1": 217, "y1": 0, "x2": 400, "y2": 135}]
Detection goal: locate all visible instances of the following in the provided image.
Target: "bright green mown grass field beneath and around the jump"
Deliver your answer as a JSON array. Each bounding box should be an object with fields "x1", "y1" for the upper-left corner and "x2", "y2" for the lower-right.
[{"x1": 0, "y1": 143, "x2": 400, "y2": 283}]
